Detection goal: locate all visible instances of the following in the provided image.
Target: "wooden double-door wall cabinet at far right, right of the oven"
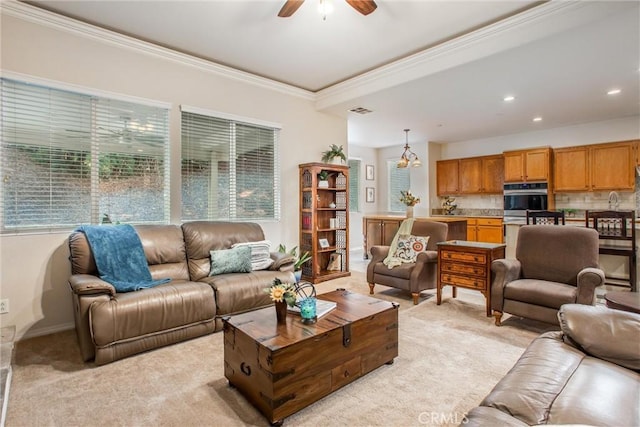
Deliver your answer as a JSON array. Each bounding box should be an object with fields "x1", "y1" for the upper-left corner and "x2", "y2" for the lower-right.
[{"x1": 553, "y1": 141, "x2": 636, "y2": 193}]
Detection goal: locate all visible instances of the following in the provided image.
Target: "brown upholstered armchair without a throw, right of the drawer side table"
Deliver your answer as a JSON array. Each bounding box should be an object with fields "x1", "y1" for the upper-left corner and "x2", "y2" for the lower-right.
[{"x1": 491, "y1": 225, "x2": 604, "y2": 326}]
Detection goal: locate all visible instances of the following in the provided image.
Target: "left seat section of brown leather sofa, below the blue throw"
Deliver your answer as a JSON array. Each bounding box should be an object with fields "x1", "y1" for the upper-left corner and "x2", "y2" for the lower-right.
[{"x1": 89, "y1": 281, "x2": 216, "y2": 347}]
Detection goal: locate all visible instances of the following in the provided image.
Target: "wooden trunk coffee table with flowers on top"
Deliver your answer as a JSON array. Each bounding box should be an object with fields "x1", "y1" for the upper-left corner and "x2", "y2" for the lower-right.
[{"x1": 224, "y1": 289, "x2": 398, "y2": 425}]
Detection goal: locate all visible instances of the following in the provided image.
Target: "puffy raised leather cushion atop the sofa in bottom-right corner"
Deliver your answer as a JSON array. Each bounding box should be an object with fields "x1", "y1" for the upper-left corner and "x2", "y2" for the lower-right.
[{"x1": 558, "y1": 304, "x2": 640, "y2": 372}]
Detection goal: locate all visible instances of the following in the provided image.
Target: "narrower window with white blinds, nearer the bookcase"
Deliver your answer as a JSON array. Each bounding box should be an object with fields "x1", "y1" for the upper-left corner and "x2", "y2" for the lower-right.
[{"x1": 182, "y1": 106, "x2": 280, "y2": 221}]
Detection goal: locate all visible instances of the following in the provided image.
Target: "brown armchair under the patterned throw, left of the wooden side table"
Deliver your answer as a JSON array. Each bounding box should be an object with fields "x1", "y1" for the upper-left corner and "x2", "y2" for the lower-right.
[{"x1": 367, "y1": 220, "x2": 448, "y2": 304}]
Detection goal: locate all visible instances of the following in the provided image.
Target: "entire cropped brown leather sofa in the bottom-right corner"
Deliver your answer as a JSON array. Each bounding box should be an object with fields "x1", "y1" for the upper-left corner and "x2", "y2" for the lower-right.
[{"x1": 460, "y1": 304, "x2": 640, "y2": 427}]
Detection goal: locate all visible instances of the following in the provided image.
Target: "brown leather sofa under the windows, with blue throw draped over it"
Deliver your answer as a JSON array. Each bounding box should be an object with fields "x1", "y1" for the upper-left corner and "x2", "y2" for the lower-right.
[{"x1": 69, "y1": 221, "x2": 295, "y2": 365}]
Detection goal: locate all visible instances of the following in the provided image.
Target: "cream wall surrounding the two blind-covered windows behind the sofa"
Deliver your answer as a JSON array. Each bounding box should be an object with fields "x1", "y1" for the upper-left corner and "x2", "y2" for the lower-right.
[{"x1": 0, "y1": 10, "x2": 347, "y2": 337}]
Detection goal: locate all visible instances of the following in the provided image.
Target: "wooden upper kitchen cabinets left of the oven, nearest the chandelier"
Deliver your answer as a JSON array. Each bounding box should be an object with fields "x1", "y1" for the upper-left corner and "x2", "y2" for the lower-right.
[{"x1": 436, "y1": 155, "x2": 504, "y2": 196}]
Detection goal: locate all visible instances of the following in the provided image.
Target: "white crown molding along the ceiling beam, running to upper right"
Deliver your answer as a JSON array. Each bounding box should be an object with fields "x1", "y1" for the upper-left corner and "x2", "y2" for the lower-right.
[{"x1": 316, "y1": 1, "x2": 610, "y2": 110}]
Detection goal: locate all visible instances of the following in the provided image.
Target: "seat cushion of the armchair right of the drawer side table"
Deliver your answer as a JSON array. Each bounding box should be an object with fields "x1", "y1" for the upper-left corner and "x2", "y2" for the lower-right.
[{"x1": 503, "y1": 279, "x2": 578, "y2": 309}]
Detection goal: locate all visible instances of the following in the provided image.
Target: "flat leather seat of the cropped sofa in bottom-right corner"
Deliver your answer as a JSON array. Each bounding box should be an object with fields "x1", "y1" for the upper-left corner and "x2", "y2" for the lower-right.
[{"x1": 478, "y1": 331, "x2": 640, "y2": 425}]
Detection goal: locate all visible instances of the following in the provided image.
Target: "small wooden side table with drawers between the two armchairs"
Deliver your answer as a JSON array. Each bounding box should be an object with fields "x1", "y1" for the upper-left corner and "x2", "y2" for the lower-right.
[{"x1": 437, "y1": 240, "x2": 506, "y2": 317}]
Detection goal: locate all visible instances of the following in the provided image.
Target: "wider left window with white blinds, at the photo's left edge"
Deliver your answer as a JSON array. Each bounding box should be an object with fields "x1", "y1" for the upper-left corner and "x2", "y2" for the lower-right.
[{"x1": 0, "y1": 79, "x2": 169, "y2": 232}]
